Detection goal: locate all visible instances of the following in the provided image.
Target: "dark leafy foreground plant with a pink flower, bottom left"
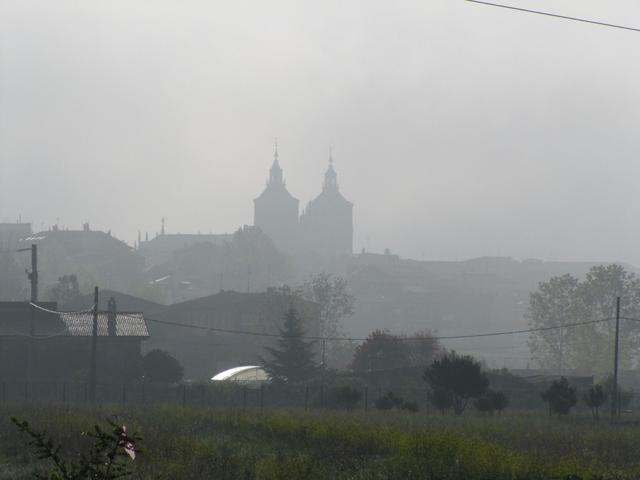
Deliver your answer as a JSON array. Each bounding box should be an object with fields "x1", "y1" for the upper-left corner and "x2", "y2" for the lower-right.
[{"x1": 11, "y1": 417, "x2": 141, "y2": 480}]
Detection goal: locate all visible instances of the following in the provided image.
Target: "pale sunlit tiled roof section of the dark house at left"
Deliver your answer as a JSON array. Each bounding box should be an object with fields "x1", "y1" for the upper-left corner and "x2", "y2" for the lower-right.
[{"x1": 60, "y1": 312, "x2": 149, "y2": 337}]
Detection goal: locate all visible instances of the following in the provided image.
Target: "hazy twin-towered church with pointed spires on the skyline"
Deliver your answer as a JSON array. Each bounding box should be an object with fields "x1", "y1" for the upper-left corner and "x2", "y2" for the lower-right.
[{"x1": 254, "y1": 147, "x2": 353, "y2": 257}]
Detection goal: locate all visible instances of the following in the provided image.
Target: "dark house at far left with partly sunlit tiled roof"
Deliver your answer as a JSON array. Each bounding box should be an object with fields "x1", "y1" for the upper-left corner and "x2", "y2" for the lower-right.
[{"x1": 0, "y1": 302, "x2": 149, "y2": 383}]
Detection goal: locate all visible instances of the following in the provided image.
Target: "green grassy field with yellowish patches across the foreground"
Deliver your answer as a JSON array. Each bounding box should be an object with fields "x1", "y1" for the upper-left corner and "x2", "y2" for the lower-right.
[{"x1": 0, "y1": 404, "x2": 640, "y2": 480}]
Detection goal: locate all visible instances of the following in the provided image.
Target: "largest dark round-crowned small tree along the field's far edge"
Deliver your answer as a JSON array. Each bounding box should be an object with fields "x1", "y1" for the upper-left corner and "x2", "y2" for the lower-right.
[{"x1": 423, "y1": 352, "x2": 489, "y2": 415}]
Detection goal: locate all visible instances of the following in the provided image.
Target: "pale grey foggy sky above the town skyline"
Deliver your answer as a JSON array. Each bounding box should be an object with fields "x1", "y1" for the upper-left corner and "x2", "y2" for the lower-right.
[{"x1": 0, "y1": 0, "x2": 640, "y2": 265}]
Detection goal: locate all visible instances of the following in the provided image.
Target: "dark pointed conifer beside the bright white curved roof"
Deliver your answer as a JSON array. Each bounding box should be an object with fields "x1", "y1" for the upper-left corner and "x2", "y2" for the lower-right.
[{"x1": 260, "y1": 307, "x2": 319, "y2": 383}]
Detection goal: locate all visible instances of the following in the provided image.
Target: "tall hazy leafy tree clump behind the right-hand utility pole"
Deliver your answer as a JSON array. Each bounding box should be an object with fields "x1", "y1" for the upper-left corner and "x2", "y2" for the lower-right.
[{"x1": 526, "y1": 265, "x2": 640, "y2": 373}]
